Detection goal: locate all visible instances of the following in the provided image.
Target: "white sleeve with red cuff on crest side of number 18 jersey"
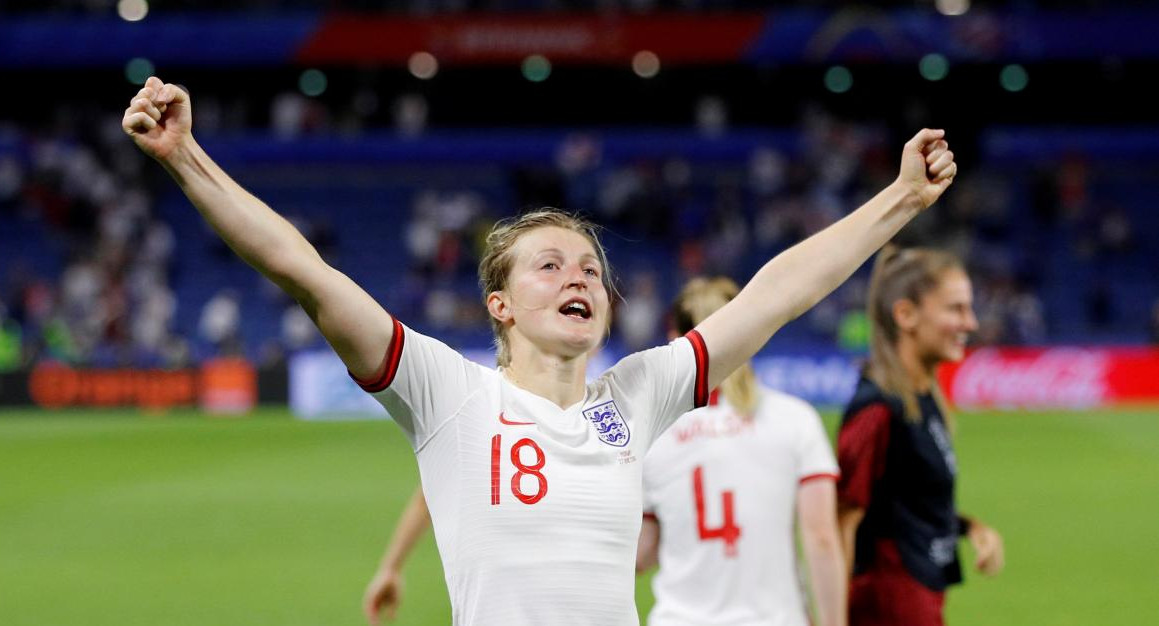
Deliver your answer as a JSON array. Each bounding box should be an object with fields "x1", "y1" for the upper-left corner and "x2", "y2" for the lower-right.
[{"x1": 605, "y1": 330, "x2": 708, "y2": 445}]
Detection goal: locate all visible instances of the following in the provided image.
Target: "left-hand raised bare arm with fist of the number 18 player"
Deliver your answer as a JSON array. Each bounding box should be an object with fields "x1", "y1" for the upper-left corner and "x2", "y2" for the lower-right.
[{"x1": 122, "y1": 77, "x2": 393, "y2": 378}]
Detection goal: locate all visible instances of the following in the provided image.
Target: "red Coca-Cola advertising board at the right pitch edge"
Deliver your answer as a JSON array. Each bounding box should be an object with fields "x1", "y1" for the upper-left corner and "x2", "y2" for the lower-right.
[{"x1": 939, "y1": 348, "x2": 1159, "y2": 409}]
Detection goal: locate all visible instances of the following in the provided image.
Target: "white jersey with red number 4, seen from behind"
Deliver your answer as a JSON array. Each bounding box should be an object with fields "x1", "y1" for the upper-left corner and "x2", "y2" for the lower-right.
[{"x1": 644, "y1": 388, "x2": 838, "y2": 626}]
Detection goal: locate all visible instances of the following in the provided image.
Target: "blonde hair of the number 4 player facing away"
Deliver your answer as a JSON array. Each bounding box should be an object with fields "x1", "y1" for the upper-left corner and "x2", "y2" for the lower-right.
[{"x1": 671, "y1": 276, "x2": 760, "y2": 418}]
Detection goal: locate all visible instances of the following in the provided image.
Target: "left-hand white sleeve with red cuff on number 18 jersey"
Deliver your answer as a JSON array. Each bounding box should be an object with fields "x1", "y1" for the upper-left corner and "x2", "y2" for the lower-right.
[{"x1": 351, "y1": 320, "x2": 482, "y2": 450}]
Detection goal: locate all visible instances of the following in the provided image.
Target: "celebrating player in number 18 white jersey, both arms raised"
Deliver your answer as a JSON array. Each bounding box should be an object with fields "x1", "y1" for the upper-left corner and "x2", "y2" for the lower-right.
[{"x1": 122, "y1": 77, "x2": 957, "y2": 626}]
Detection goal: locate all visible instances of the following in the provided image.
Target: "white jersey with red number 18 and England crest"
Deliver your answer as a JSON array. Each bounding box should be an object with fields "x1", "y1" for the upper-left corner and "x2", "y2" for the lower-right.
[{"x1": 360, "y1": 322, "x2": 708, "y2": 626}]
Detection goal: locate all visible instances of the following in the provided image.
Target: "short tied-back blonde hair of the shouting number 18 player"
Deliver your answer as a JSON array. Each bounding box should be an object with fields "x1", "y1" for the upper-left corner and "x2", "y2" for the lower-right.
[{"x1": 479, "y1": 206, "x2": 619, "y2": 367}]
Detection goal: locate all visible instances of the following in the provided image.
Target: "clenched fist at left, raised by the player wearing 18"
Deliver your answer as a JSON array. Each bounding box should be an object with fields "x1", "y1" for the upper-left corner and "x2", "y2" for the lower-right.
[{"x1": 121, "y1": 77, "x2": 194, "y2": 161}]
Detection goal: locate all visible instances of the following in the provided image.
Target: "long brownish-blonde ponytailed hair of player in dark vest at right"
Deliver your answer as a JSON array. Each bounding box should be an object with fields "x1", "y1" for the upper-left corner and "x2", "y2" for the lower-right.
[{"x1": 865, "y1": 243, "x2": 965, "y2": 429}]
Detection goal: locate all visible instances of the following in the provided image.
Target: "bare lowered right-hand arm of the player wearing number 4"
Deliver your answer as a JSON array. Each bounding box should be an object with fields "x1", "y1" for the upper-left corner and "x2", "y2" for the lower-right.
[{"x1": 796, "y1": 479, "x2": 848, "y2": 626}]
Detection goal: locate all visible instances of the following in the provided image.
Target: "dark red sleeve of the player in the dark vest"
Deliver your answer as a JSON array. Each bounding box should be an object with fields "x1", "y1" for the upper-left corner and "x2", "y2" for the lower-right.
[{"x1": 837, "y1": 402, "x2": 890, "y2": 509}]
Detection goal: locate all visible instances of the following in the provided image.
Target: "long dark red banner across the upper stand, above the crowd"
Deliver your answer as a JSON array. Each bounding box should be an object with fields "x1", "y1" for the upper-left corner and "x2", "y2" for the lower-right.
[{"x1": 297, "y1": 13, "x2": 768, "y2": 64}]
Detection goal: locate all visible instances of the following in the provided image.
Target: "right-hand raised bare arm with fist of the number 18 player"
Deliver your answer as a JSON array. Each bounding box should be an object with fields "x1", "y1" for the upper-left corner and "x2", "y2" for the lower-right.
[{"x1": 697, "y1": 129, "x2": 957, "y2": 388}]
